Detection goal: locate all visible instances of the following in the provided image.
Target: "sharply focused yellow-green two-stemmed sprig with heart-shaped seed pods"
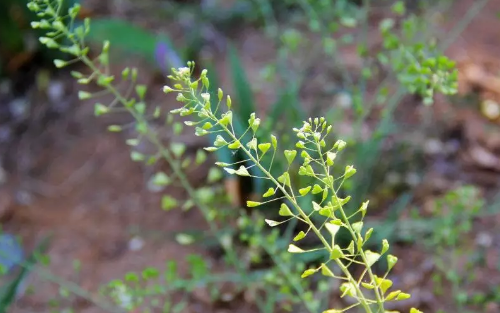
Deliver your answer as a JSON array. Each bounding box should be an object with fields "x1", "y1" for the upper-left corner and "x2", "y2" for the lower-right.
[{"x1": 164, "y1": 62, "x2": 418, "y2": 312}]
